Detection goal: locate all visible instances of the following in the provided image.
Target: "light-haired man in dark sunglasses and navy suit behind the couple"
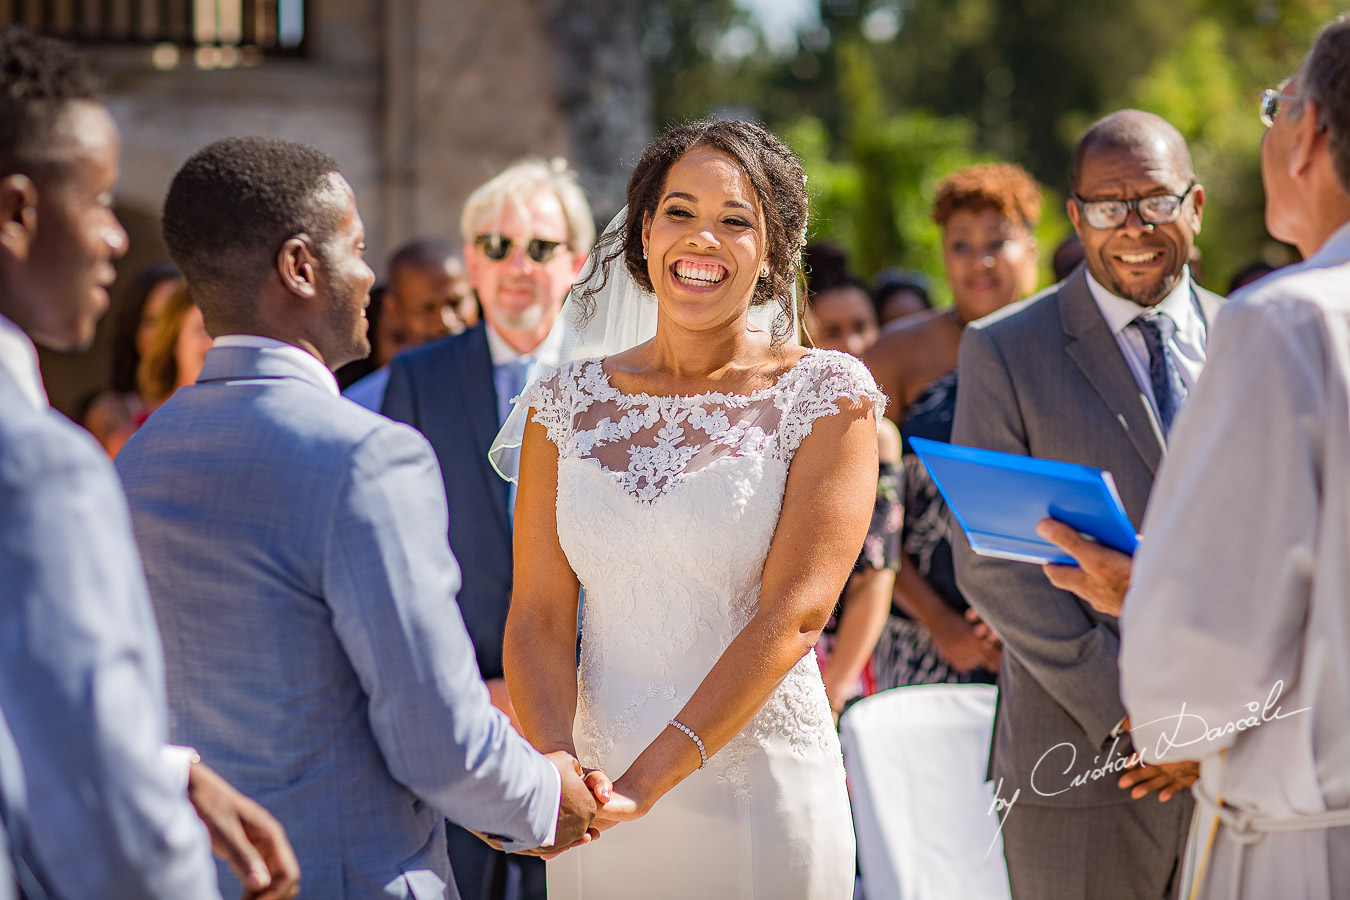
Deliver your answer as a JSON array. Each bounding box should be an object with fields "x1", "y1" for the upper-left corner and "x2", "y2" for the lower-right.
[{"x1": 381, "y1": 159, "x2": 595, "y2": 900}]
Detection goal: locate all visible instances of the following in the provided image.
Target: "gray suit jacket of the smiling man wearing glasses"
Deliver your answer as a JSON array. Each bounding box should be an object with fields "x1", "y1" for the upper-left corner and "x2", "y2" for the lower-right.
[{"x1": 952, "y1": 267, "x2": 1223, "y2": 807}]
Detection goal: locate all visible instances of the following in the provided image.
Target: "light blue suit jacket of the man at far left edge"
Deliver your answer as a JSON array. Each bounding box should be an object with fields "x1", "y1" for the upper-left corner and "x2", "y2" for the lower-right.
[{"x1": 0, "y1": 366, "x2": 220, "y2": 900}]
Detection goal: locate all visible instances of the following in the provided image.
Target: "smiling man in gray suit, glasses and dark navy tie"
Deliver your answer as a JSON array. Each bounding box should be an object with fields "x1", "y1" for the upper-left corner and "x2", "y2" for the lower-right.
[{"x1": 952, "y1": 111, "x2": 1222, "y2": 900}]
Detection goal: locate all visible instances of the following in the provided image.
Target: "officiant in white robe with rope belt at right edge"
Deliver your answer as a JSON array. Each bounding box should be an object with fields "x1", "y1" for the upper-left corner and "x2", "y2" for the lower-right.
[{"x1": 1121, "y1": 18, "x2": 1350, "y2": 900}]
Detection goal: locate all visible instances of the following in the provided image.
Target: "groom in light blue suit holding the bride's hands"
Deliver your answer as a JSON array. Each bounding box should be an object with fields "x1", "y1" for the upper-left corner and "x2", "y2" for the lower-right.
[{"x1": 117, "y1": 138, "x2": 595, "y2": 900}]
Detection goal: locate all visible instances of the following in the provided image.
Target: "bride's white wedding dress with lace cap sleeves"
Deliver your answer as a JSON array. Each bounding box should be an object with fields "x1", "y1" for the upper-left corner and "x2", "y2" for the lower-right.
[{"x1": 520, "y1": 351, "x2": 884, "y2": 900}]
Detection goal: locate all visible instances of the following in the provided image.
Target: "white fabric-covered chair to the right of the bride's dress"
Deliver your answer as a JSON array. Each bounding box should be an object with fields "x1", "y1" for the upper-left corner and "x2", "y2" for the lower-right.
[{"x1": 840, "y1": 684, "x2": 1010, "y2": 900}]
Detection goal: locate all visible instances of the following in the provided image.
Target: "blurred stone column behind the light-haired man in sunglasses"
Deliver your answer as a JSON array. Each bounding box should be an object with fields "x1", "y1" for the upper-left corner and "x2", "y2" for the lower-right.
[{"x1": 382, "y1": 0, "x2": 651, "y2": 247}]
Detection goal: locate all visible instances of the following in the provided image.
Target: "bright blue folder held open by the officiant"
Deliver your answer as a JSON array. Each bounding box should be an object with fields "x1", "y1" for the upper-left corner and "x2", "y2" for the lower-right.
[{"x1": 910, "y1": 437, "x2": 1139, "y2": 565}]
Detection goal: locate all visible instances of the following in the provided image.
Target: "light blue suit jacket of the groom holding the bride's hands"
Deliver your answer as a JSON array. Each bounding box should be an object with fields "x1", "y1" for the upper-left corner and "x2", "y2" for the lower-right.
[{"x1": 117, "y1": 347, "x2": 558, "y2": 900}]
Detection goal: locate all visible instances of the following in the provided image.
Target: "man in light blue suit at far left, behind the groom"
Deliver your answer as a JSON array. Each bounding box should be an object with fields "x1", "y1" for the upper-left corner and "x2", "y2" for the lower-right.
[{"x1": 0, "y1": 27, "x2": 298, "y2": 900}]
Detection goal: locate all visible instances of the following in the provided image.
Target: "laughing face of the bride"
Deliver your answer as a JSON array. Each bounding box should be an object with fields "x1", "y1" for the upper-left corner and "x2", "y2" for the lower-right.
[{"x1": 643, "y1": 147, "x2": 767, "y2": 329}]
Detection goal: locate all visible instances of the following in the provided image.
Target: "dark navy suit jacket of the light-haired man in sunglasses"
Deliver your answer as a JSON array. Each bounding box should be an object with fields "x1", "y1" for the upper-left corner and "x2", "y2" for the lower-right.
[{"x1": 381, "y1": 324, "x2": 512, "y2": 679}]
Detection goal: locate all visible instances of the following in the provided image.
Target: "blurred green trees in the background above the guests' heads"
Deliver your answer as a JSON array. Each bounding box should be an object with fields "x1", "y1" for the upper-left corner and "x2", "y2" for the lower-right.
[{"x1": 644, "y1": 0, "x2": 1343, "y2": 289}]
